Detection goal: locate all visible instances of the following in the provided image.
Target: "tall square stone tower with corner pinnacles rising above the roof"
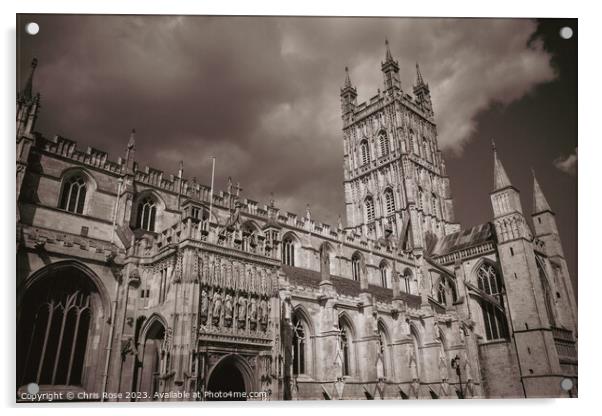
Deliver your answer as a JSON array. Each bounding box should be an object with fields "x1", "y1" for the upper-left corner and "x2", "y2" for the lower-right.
[{"x1": 341, "y1": 41, "x2": 458, "y2": 251}]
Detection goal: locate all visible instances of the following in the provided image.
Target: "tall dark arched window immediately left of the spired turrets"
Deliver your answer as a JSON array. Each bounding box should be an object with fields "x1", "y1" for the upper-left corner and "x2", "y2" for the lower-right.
[{"x1": 477, "y1": 263, "x2": 508, "y2": 340}]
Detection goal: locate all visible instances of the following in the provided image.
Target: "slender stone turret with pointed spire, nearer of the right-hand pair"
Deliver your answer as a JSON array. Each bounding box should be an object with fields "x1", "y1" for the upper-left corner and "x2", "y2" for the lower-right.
[{"x1": 491, "y1": 145, "x2": 562, "y2": 397}]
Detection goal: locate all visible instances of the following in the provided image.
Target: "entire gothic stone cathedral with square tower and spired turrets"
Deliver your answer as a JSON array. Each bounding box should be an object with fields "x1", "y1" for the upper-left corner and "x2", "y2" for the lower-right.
[{"x1": 16, "y1": 44, "x2": 577, "y2": 402}]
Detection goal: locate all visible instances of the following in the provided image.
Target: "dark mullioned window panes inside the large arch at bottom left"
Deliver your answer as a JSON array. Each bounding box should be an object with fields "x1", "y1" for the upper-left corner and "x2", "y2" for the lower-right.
[{"x1": 17, "y1": 270, "x2": 94, "y2": 386}]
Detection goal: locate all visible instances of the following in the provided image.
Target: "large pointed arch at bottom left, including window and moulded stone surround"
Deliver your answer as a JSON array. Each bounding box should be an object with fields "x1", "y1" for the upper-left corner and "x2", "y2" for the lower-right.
[{"x1": 17, "y1": 260, "x2": 110, "y2": 388}]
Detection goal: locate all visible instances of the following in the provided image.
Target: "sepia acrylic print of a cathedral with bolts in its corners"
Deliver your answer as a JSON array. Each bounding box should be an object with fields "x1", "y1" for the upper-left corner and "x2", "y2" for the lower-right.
[{"x1": 11, "y1": 14, "x2": 585, "y2": 406}]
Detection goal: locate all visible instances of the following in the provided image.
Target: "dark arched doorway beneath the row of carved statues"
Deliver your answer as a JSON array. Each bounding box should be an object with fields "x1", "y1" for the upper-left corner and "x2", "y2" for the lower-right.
[{"x1": 205, "y1": 355, "x2": 251, "y2": 401}]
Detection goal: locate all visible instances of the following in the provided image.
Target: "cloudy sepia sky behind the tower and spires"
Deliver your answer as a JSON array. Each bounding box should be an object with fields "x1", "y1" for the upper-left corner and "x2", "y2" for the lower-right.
[{"x1": 17, "y1": 15, "x2": 577, "y2": 288}]
